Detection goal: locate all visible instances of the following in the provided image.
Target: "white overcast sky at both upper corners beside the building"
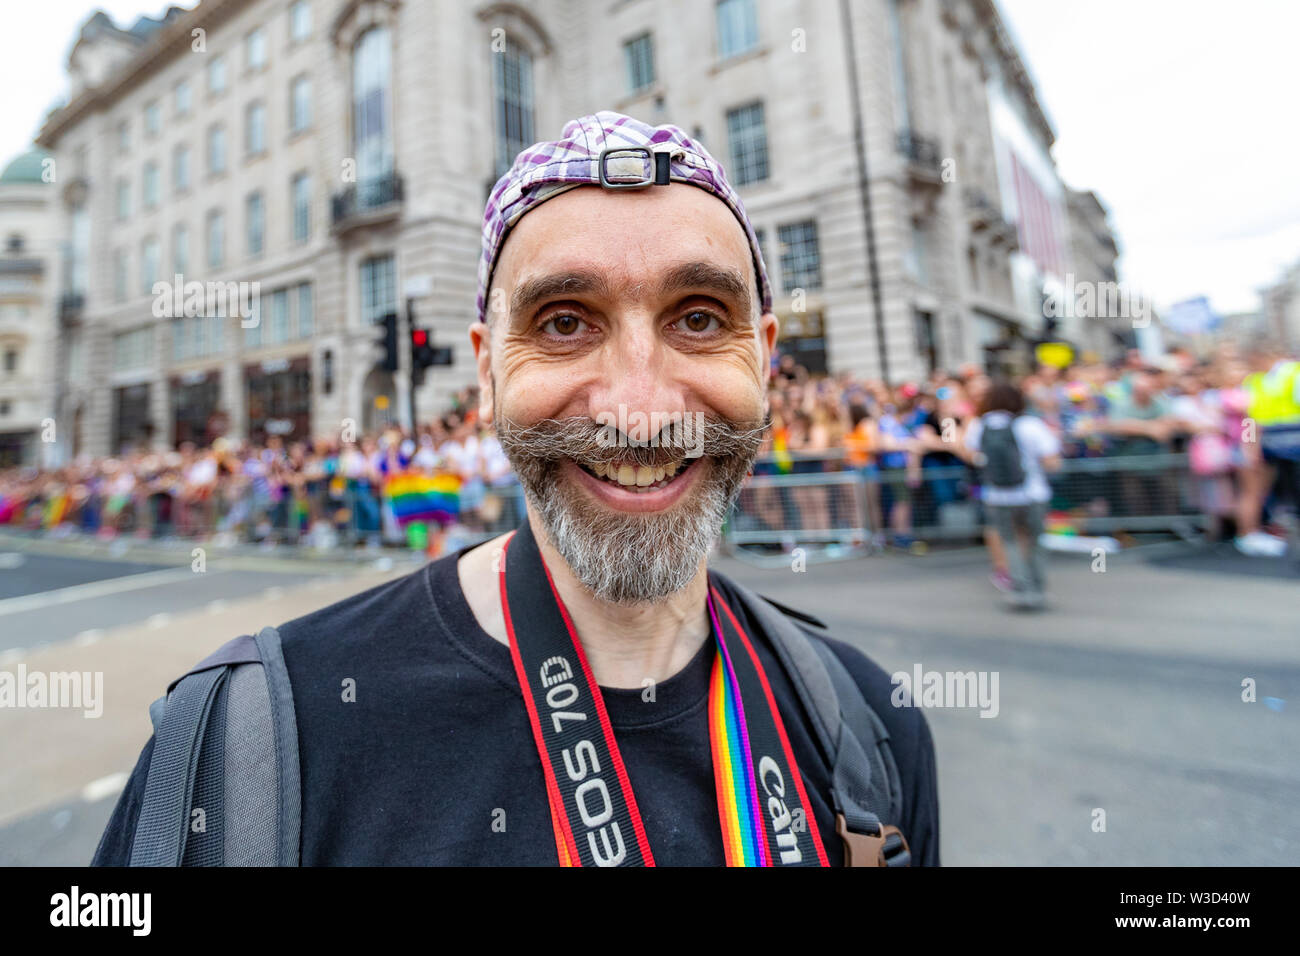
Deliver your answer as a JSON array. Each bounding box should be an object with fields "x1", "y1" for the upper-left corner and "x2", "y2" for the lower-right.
[{"x1": 0, "y1": 0, "x2": 1300, "y2": 312}]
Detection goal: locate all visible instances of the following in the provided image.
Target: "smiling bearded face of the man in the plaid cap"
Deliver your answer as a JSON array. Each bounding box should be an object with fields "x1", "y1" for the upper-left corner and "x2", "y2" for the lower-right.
[{"x1": 471, "y1": 183, "x2": 776, "y2": 604}]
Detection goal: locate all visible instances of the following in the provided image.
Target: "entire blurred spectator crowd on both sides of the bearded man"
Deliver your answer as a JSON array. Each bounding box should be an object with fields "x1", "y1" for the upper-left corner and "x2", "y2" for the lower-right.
[{"x1": 0, "y1": 343, "x2": 1300, "y2": 564}]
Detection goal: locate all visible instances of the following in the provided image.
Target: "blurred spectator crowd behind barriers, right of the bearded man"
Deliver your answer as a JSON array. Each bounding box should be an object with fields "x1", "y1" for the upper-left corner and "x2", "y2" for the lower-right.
[{"x1": 746, "y1": 342, "x2": 1300, "y2": 555}]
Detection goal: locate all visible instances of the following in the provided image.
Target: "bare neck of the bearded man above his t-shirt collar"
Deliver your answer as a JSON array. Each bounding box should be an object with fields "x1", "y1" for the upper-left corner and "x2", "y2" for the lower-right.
[{"x1": 458, "y1": 523, "x2": 710, "y2": 688}]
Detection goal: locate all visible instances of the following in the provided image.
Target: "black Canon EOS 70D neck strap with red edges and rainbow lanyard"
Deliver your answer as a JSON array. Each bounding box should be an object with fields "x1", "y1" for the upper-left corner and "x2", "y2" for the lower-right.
[{"x1": 501, "y1": 520, "x2": 829, "y2": 866}]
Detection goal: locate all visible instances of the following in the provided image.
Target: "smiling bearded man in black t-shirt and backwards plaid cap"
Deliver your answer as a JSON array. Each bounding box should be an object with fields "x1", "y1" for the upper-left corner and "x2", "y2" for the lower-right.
[{"x1": 96, "y1": 113, "x2": 939, "y2": 866}]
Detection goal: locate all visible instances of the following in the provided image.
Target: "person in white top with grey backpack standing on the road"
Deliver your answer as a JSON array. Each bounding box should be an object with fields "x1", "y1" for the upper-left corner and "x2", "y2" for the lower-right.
[{"x1": 965, "y1": 382, "x2": 1061, "y2": 610}]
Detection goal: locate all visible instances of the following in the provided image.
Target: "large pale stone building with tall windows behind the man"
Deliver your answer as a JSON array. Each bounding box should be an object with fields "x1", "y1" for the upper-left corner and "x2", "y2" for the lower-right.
[{"x1": 39, "y1": 0, "x2": 1107, "y2": 454}]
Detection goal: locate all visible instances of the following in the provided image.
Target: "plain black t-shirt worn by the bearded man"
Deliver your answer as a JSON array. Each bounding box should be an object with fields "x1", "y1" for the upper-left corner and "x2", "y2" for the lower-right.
[{"x1": 94, "y1": 554, "x2": 939, "y2": 866}]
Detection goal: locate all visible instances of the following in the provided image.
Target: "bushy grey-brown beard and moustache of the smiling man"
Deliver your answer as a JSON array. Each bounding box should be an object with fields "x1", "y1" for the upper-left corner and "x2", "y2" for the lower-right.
[{"x1": 497, "y1": 418, "x2": 767, "y2": 606}]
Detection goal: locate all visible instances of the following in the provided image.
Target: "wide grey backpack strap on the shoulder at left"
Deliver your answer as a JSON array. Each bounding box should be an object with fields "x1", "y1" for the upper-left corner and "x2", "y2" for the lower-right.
[{"x1": 131, "y1": 627, "x2": 302, "y2": 866}]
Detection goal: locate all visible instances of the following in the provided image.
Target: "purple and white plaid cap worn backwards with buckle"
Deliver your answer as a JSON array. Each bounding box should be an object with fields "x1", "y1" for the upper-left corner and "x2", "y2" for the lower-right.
[{"x1": 478, "y1": 111, "x2": 772, "y2": 321}]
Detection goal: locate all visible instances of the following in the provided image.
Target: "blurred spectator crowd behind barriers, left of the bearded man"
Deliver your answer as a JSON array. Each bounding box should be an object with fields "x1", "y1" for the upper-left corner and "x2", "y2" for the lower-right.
[{"x1": 0, "y1": 389, "x2": 517, "y2": 548}]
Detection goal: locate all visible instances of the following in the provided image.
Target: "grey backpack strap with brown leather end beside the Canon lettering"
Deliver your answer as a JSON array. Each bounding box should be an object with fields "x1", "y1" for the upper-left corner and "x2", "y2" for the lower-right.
[{"x1": 728, "y1": 581, "x2": 911, "y2": 866}]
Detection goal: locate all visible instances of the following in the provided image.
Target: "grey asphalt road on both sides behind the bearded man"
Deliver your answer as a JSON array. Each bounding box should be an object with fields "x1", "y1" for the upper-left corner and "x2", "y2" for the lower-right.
[{"x1": 0, "y1": 538, "x2": 1300, "y2": 865}]
